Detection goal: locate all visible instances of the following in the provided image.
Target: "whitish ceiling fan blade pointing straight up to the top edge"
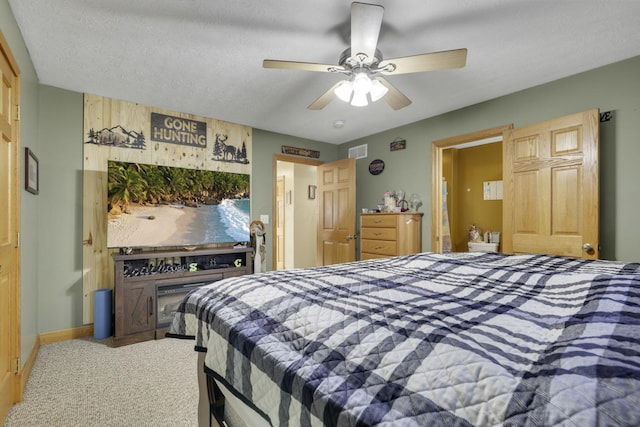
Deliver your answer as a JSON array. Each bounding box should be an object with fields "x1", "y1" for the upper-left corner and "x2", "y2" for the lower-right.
[{"x1": 351, "y1": 2, "x2": 384, "y2": 64}]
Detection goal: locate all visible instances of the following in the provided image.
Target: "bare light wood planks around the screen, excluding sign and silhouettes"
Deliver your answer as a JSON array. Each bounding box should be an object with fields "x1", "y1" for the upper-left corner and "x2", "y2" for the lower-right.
[{"x1": 82, "y1": 94, "x2": 252, "y2": 324}]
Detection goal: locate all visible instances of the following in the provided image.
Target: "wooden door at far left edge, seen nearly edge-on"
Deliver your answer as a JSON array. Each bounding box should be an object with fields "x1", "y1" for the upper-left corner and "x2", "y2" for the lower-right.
[{"x1": 0, "y1": 33, "x2": 22, "y2": 424}]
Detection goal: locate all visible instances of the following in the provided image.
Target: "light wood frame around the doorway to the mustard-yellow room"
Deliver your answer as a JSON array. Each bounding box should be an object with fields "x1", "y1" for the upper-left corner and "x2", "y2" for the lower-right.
[{"x1": 431, "y1": 124, "x2": 513, "y2": 253}]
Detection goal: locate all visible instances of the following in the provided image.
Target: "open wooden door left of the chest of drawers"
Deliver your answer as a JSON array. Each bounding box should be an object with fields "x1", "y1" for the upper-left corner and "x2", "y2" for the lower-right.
[{"x1": 317, "y1": 158, "x2": 356, "y2": 265}]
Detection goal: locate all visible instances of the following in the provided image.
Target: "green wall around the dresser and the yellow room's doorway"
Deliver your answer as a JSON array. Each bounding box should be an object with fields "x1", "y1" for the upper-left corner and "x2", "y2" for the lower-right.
[{"x1": 339, "y1": 57, "x2": 640, "y2": 262}]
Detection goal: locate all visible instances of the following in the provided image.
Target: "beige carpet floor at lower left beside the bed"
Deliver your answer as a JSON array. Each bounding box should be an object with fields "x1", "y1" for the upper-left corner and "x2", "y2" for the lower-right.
[{"x1": 5, "y1": 338, "x2": 198, "y2": 427}]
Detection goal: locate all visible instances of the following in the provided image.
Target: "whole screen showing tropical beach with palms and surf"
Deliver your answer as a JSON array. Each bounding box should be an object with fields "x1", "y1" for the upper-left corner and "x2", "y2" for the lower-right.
[{"x1": 107, "y1": 161, "x2": 250, "y2": 248}]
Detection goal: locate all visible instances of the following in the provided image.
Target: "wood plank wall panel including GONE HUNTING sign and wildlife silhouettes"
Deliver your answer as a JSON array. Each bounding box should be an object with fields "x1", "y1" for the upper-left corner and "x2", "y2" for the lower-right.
[{"x1": 82, "y1": 94, "x2": 252, "y2": 324}]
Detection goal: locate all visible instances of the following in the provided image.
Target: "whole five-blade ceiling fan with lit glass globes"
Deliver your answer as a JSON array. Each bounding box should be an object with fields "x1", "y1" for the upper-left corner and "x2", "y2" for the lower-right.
[{"x1": 262, "y1": 2, "x2": 467, "y2": 110}]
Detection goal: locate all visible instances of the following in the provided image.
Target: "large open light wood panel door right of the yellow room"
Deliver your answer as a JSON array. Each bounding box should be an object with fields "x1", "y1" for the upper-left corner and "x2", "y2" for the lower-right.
[{"x1": 502, "y1": 109, "x2": 599, "y2": 259}]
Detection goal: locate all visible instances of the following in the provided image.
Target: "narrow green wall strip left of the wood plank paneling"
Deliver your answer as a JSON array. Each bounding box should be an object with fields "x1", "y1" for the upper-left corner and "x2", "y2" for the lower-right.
[{"x1": 37, "y1": 86, "x2": 87, "y2": 333}]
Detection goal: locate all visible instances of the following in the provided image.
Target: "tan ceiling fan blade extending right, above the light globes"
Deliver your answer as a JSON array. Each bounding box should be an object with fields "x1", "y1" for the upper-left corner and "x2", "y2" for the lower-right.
[{"x1": 379, "y1": 49, "x2": 467, "y2": 75}]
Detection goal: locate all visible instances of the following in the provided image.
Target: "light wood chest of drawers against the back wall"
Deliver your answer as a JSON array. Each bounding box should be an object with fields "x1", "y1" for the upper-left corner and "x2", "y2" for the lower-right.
[{"x1": 360, "y1": 212, "x2": 423, "y2": 260}]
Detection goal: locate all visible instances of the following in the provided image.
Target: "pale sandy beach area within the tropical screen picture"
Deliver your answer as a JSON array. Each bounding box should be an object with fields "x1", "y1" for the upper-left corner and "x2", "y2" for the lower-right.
[{"x1": 107, "y1": 205, "x2": 205, "y2": 248}]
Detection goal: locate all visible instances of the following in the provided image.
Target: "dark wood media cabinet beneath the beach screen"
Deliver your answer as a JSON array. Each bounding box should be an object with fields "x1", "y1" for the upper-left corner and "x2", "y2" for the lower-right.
[{"x1": 113, "y1": 248, "x2": 253, "y2": 347}]
